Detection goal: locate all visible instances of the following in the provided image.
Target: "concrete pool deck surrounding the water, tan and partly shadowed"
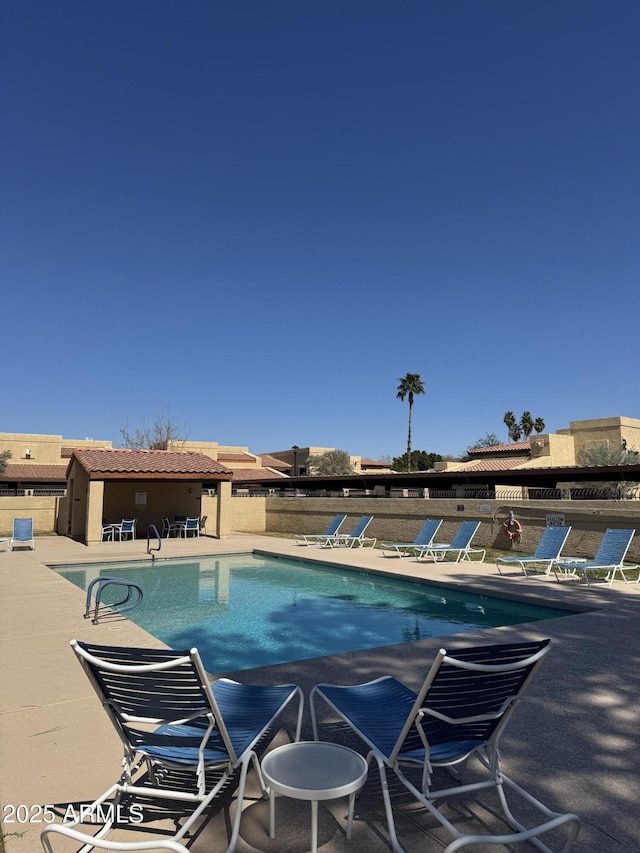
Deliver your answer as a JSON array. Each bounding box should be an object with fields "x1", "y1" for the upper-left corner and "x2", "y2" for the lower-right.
[{"x1": 0, "y1": 534, "x2": 640, "y2": 853}]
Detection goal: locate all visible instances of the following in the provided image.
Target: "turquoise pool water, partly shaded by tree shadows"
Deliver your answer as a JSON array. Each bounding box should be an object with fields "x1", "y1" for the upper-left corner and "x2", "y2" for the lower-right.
[{"x1": 56, "y1": 554, "x2": 568, "y2": 673}]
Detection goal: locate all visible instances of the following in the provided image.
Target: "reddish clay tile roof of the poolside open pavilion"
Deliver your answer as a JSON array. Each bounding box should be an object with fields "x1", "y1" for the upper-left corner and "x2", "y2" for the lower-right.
[{"x1": 69, "y1": 447, "x2": 231, "y2": 480}]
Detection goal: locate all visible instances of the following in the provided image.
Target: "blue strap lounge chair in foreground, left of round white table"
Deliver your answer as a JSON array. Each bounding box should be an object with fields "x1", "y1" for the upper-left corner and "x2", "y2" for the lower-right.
[{"x1": 40, "y1": 640, "x2": 303, "y2": 853}]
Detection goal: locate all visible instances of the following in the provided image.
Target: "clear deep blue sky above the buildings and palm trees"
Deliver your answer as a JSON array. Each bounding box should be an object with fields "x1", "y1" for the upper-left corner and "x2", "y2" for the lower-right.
[{"x1": 0, "y1": 0, "x2": 640, "y2": 458}]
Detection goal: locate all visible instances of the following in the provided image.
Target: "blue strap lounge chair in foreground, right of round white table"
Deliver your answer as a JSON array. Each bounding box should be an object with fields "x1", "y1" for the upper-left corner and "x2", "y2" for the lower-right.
[{"x1": 310, "y1": 640, "x2": 580, "y2": 853}]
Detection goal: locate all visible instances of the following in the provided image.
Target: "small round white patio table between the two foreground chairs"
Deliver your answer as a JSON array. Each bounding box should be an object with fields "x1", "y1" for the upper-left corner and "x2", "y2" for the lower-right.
[{"x1": 261, "y1": 741, "x2": 369, "y2": 853}]
